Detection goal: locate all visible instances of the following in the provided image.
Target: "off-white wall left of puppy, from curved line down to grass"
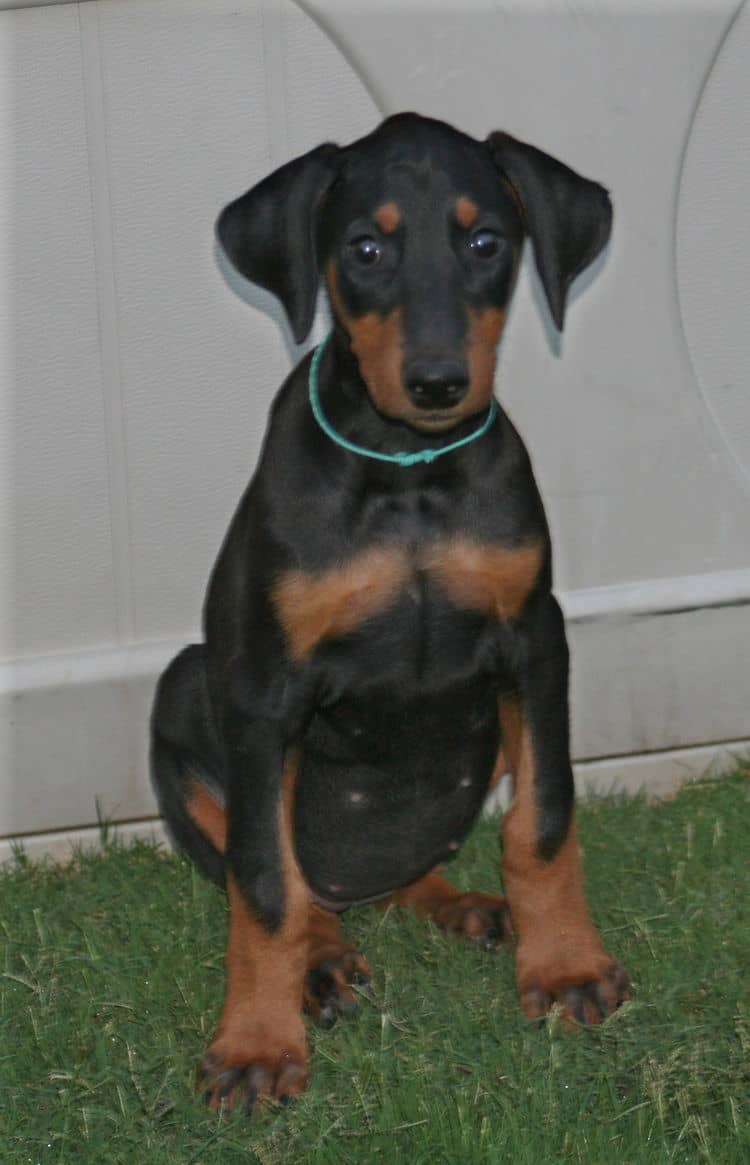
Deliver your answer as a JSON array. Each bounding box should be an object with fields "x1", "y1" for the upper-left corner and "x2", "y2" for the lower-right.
[{"x1": 0, "y1": 0, "x2": 380, "y2": 857}]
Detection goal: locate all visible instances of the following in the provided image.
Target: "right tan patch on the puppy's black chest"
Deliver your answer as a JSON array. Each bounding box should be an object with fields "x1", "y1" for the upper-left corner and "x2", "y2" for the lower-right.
[{"x1": 425, "y1": 538, "x2": 544, "y2": 619}]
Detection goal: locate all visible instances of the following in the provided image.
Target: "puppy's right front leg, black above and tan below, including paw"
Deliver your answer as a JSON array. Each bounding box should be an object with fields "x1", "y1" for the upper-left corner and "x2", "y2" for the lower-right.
[{"x1": 500, "y1": 594, "x2": 629, "y2": 1023}]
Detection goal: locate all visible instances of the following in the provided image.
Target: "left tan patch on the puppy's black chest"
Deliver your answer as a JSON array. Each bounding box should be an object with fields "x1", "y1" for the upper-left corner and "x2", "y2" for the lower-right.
[{"x1": 273, "y1": 548, "x2": 411, "y2": 659}]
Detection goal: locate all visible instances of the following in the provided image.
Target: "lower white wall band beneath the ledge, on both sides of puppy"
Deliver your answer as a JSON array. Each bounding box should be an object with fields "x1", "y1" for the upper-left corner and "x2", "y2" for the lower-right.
[{"x1": 0, "y1": 571, "x2": 750, "y2": 852}]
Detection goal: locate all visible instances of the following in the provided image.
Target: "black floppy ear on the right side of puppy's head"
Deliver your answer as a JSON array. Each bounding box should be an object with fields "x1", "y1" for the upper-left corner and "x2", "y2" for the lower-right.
[{"x1": 487, "y1": 132, "x2": 611, "y2": 331}]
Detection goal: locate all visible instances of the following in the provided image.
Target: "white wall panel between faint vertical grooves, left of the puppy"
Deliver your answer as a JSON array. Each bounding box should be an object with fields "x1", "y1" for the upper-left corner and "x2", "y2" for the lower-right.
[{"x1": 98, "y1": 0, "x2": 279, "y2": 638}]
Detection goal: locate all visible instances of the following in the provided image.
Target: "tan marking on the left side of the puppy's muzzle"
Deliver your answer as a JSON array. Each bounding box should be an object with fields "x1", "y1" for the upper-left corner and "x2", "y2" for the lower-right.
[{"x1": 326, "y1": 263, "x2": 408, "y2": 417}]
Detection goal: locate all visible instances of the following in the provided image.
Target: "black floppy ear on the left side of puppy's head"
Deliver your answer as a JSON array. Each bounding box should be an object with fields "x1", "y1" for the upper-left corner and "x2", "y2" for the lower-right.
[{"x1": 217, "y1": 143, "x2": 339, "y2": 344}]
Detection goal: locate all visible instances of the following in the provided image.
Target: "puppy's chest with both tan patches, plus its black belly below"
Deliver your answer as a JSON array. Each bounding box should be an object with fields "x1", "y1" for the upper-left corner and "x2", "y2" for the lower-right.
[{"x1": 273, "y1": 505, "x2": 543, "y2": 903}]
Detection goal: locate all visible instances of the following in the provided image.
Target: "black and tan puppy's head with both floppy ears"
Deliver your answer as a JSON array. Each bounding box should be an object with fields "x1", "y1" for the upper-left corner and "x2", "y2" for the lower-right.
[{"x1": 217, "y1": 113, "x2": 611, "y2": 431}]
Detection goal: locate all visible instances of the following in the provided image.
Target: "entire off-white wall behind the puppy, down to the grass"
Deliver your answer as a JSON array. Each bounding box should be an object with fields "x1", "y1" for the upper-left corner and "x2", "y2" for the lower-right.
[{"x1": 0, "y1": 0, "x2": 750, "y2": 849}]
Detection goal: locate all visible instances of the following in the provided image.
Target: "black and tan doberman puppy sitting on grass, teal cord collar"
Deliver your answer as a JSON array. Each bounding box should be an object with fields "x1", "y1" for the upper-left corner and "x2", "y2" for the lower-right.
[{"x1": 153, "y1": 114, "x2": 629, "y2": 1111}]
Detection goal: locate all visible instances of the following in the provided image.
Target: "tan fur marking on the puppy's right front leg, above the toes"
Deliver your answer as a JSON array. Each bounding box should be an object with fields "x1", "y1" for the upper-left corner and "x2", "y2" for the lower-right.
[{"x1": 500, "y1": 700, "x2": 611, "y2": 1004}]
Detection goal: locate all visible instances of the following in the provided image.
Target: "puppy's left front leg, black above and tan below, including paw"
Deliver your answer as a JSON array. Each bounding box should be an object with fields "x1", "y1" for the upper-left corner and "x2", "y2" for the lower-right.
[{"x1": 199, "y1": 676, "x2": 310, "y2": 1111}]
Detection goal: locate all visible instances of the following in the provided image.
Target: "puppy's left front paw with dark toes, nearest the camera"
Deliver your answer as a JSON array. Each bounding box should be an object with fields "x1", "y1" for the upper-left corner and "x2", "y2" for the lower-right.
[{"x1": 197, "y1": 1045, "x2": 307, "y2": 1116}]
